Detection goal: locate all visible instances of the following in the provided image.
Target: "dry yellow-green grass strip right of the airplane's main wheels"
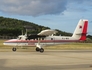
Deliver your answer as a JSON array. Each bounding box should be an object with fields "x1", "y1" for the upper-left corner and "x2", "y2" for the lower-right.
[{"x1": 45, "y1": 43, "x2": 92, "y2": 50}]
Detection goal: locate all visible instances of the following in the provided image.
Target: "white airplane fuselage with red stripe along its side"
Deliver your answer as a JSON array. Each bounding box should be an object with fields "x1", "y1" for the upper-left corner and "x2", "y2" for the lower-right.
[{"x1": 4, "y1": 36, "x2": 80, "y2": 46}]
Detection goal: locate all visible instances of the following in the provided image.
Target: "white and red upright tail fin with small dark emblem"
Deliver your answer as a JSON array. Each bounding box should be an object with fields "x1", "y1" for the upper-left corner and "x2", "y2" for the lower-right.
[{"x1": 72, "y1": 19, "x2": 88, "y2": 41}]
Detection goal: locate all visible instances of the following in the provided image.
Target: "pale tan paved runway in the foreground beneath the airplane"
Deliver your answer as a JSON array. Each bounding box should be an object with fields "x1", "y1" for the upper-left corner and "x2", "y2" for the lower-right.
[{"x1": 0, "y1": 50, "x2": 92, "y2": 70}]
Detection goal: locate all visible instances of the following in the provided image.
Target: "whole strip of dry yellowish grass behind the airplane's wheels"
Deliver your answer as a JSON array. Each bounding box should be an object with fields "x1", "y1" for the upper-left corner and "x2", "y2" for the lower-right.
[{"x1": 0, "y1": 40, "x2": 92, "y2": 52}]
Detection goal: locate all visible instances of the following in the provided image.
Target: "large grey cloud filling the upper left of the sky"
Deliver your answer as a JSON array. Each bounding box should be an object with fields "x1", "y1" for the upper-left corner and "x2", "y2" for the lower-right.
[{"x1": 0, "y1": 0, "x2": 67, "y2": 16}]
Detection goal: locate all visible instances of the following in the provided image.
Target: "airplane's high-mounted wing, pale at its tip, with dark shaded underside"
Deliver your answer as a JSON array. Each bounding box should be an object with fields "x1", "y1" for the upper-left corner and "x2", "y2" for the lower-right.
[{"x1": 27, "y1": 30, "x2": 57, "y2": 40}]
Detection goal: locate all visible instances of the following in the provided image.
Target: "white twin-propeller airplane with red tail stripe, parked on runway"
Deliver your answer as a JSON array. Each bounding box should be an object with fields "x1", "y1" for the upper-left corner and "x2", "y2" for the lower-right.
[{"x1": 3, "y1": 19, "x2": 88, "y2": 53}]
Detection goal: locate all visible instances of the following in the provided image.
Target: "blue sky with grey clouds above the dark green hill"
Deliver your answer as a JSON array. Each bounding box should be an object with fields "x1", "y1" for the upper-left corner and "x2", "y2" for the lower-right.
[{"x1": 0, "y1": 0, "x2": 92, "y2": 35}]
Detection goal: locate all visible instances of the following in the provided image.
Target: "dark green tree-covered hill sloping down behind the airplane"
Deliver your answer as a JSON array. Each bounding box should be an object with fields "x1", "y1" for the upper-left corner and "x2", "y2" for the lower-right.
[{"x1": 0, "y1": 17, "x2": 72, "y2": 36}]
